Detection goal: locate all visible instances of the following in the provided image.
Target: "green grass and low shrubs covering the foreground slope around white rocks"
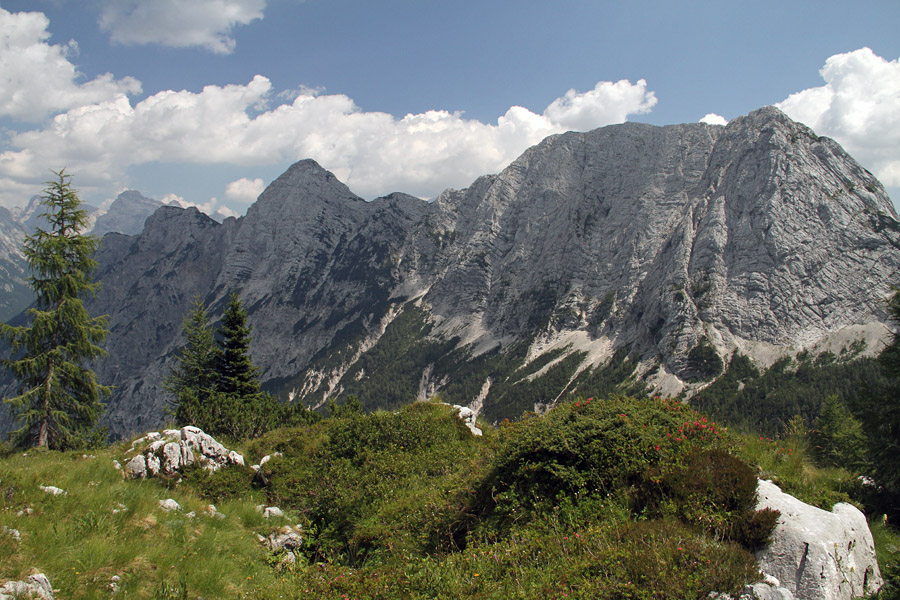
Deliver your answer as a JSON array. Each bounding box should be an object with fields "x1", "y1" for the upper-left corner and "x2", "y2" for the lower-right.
[{"x1": 0, "y1": 398, "x2": 900, "y2": 600}]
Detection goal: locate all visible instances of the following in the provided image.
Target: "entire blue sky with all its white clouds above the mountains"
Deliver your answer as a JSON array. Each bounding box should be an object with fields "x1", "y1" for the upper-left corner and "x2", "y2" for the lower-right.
[{"x1": 0, "y1": 0, "x2": 900, "y2": 215}]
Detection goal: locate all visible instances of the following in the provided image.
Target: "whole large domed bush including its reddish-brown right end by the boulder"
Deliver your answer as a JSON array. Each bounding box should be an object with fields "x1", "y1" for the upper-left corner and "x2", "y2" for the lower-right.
[{"x1": 456, "y1": 397, "x2": 774, "y2": 547}]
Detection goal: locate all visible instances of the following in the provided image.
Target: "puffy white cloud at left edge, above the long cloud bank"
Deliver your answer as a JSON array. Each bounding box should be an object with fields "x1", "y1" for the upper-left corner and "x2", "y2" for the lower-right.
[{"x1": 0, "y1": 8, "x2": 141, "y2": 121}]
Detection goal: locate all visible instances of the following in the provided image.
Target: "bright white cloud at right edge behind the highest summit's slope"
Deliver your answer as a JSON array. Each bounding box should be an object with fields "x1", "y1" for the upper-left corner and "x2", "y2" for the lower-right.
[{"x1": 776, "y1": 48, "x2": 900, "y2": 186}]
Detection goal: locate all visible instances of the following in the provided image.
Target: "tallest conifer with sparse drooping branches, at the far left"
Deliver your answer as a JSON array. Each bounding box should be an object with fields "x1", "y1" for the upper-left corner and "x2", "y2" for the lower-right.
[{"x1": 0, "y1": 169, "x2": 109, "y2": 448}]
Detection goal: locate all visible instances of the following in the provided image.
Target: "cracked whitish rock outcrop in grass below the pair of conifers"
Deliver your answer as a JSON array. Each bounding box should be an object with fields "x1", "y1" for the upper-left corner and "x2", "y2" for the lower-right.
[{"x1": 125, "y1": 426, "x2": 244, "y2": 479}]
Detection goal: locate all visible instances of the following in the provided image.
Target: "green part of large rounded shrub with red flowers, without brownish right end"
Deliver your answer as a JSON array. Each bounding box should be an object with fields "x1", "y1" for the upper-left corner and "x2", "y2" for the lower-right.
[{"x1": 460, "y1": 397, "x2": 727, "y2": 535}]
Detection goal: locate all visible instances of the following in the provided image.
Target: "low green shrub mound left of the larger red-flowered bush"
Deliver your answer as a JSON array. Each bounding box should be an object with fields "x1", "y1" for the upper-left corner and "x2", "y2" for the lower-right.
[{"x1": 251, "y1": 403, "x2": 482, "y2": 564}]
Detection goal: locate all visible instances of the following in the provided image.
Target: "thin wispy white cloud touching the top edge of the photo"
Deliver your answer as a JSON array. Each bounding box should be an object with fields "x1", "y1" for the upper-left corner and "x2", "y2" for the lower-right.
[{"x1": 100, "y1": 0, "x2": 266, "y2": 54}]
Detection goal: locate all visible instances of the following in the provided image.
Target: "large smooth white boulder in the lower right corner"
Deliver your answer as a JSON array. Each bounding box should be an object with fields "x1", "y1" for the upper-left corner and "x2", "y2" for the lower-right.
[{"x1": 757, "y1": 481, "x2": 884, "y2": 600}]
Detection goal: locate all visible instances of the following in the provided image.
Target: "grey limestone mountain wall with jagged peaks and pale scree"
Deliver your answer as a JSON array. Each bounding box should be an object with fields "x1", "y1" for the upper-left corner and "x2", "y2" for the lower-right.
[{"x1": 8, "y1": 108, "x2": 900, "y2": 433}]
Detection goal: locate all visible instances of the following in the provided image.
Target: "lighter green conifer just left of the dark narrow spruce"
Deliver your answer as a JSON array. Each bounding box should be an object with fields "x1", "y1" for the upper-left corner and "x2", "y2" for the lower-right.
[{"x1": 163, "y1": 298, "x2": 220, "y2": 426}]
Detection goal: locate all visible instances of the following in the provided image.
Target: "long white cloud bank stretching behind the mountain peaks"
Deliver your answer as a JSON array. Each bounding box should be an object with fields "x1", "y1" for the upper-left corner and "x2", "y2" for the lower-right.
[{"x1": 0, "y1": 75, "x2": 656, "y2": 204}]
